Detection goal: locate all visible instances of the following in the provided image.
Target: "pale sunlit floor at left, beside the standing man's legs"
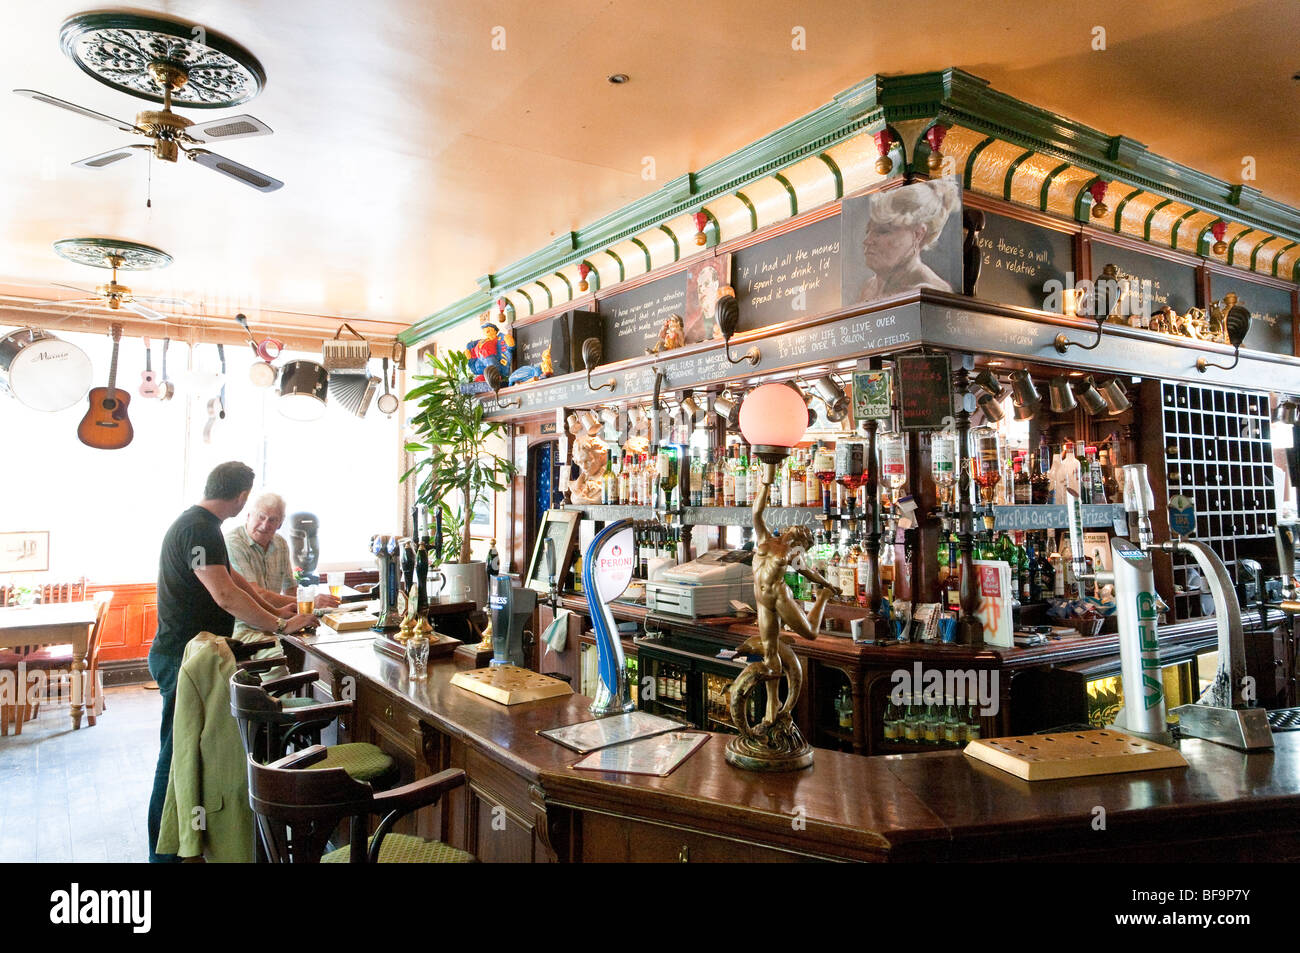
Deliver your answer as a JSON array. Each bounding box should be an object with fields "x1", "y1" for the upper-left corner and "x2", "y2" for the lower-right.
[{"x1": 0, "y1": 685, "x2": 163, "y2": 863}]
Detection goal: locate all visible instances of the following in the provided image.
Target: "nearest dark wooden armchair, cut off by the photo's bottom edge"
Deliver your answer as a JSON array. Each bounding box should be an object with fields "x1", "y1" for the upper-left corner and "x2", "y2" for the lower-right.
[{"x1": 248, "y1": 745, "x2": 475, "y2": 863}]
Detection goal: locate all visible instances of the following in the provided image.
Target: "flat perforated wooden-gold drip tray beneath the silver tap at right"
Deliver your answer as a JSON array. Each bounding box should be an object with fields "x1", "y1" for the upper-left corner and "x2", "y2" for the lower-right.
[{"x1": 965, "y1": 728, "x2": 1187, "y2": 781}]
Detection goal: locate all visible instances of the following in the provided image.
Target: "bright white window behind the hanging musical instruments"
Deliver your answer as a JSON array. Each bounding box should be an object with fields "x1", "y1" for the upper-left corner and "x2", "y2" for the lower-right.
[{"x1": 0, "y1": 329, "x2": 402, "y2": 584}]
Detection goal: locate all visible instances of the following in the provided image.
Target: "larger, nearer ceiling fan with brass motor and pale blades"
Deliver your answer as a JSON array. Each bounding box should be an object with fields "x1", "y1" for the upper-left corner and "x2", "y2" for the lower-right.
[{"x1": 14, "y1": 60, "x2": 285, "y2": 192}]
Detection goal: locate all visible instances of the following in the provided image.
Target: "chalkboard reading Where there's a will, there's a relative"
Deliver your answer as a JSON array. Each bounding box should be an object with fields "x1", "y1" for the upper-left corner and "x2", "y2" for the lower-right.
[{"x1": 975, "y1": 212, "x2": 1074, "y2": 313}]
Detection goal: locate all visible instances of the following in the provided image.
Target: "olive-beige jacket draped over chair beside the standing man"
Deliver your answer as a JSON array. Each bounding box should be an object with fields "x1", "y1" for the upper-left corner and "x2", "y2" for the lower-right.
[{"x1": 157, "y1": 632, "x2": 254, "y2": 863}]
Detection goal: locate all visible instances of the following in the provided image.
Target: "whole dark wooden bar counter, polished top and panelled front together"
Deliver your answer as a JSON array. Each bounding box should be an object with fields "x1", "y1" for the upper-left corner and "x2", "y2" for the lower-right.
[{"x1": 286, "y1": 628, "x2": 1300, "y2": 862}]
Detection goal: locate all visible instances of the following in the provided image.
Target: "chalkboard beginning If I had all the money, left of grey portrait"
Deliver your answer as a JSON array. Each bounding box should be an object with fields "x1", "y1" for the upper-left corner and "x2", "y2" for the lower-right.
[{"x1": 732, "y1": 216, "x2": 840, "y2": 332}]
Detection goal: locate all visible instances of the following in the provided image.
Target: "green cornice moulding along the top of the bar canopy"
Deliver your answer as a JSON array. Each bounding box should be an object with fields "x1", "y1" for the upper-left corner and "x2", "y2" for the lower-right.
[{"x1": 399, "y1": 68, "x2": 1300, "y2": 345}]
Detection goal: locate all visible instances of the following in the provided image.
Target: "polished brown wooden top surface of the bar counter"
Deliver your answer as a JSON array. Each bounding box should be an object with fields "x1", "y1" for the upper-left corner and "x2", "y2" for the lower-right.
[{"x1": 289, "y1": 629, "x2": 1300, "y2": 859}]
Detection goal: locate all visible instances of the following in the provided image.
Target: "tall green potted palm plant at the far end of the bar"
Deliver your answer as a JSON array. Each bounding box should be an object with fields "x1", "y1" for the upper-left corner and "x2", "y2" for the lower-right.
[{"x1": 402, "y1": 351, "x2": 515, "y2": 606}]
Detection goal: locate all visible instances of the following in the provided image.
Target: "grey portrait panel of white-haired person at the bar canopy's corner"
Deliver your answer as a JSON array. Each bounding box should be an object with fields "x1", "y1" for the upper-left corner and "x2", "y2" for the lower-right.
[{"x1": 841, "y1": 176, "x2": 962, "y2": 307}]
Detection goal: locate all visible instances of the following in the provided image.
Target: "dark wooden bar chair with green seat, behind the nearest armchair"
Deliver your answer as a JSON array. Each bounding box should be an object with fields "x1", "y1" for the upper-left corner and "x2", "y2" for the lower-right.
[{"x1": 230, "y1": 671, "x2": 397, "y2": 788}]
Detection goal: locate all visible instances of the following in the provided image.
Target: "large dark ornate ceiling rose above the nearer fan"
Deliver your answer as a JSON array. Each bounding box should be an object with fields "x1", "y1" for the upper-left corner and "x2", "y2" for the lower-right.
[{"x1": 59, "y1": 13, "x2": 267, "y2": 109}]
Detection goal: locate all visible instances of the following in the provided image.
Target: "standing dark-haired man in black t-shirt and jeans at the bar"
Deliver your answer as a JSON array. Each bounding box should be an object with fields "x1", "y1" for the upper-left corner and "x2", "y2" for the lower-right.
[{"x1": 148, "y1": 460, "x2": 316, "y2": 863}]
